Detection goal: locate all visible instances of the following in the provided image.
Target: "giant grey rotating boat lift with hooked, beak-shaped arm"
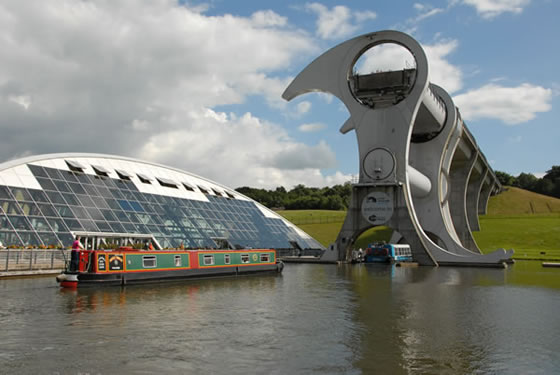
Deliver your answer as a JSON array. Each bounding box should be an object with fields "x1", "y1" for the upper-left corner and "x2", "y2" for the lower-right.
[{"x1": 282, "y1": 31, "x2": 513, "y2": 266}]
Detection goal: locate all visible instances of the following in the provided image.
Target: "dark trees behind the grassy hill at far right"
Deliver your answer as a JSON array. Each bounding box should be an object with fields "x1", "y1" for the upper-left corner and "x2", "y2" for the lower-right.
[{"x1": 496, "y1": 165, "x2": 560, "y2": 198}]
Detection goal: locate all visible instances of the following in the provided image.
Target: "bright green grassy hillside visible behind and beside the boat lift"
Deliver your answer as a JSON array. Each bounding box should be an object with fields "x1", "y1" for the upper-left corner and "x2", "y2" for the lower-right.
[{"x1": 278, "y1": 187, "x2": 560, "y2": 260}]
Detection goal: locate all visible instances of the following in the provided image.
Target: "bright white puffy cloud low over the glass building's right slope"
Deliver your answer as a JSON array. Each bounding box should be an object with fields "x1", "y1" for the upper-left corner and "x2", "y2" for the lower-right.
[{"x1": 137, "y1": 109, "x2": 342, "y2": 188}]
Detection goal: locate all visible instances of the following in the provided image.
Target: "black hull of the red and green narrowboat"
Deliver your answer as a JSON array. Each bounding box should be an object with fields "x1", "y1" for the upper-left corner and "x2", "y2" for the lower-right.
[{"x1": 67, "y1": 263, "x2": 284, "y2": 287}]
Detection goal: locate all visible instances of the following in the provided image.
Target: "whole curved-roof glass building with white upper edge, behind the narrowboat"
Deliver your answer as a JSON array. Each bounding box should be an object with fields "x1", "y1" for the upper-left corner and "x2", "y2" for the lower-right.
[{"x1": 0, "y1": 153, "x2": 324, "y2": 250}]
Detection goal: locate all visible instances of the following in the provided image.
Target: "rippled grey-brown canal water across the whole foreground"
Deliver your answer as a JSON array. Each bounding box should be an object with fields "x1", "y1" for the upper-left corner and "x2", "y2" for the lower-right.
[{"x1": 0, "y1": 262, "x2": 560, "y2": 374}]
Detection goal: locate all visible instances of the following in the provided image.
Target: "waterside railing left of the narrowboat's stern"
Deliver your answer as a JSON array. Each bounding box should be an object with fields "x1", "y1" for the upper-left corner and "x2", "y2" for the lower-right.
[{"x1": 0, "y1": 249, "x2": 71, "y2": 272}]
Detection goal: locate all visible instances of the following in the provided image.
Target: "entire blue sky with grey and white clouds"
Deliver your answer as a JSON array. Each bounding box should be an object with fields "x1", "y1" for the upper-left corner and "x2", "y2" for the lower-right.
[{"x1": 0, "y1": 0, "x2": 560, "y2": 189}]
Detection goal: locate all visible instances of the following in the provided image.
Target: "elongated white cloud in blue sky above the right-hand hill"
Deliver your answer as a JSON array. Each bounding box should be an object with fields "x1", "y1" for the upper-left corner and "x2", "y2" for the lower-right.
[{"x1": 453, "y1": 83, "x2": 552, "y2": 125}]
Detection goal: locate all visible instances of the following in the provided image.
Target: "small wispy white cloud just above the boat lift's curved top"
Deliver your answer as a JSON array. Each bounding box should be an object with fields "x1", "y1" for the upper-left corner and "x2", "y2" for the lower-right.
[{"x1": 305, "y1": 3, "x2": 377, "y2": 39}]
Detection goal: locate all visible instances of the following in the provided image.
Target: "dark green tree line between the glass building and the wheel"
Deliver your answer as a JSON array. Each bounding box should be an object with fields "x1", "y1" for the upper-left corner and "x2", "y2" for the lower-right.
[{"x1": 235, "y1": 182, "x2": 352, "y2": 210}]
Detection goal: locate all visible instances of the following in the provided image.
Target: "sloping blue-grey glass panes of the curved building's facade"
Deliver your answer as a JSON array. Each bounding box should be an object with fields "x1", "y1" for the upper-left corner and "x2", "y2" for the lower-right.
[{"x1": 0, "y1": 159, "x2": 322, "y2": 253}]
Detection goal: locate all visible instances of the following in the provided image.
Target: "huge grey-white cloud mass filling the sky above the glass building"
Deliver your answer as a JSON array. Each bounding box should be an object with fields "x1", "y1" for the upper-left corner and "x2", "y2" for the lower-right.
[{"x1": 0, "y1": 0, "x2": 352, "y2": 187}]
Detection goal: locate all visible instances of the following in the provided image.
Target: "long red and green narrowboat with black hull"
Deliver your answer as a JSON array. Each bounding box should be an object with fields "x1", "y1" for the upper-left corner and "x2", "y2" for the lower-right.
[{"x1": 56, "y1": 247, "x2": 284, "y2": 288}]
